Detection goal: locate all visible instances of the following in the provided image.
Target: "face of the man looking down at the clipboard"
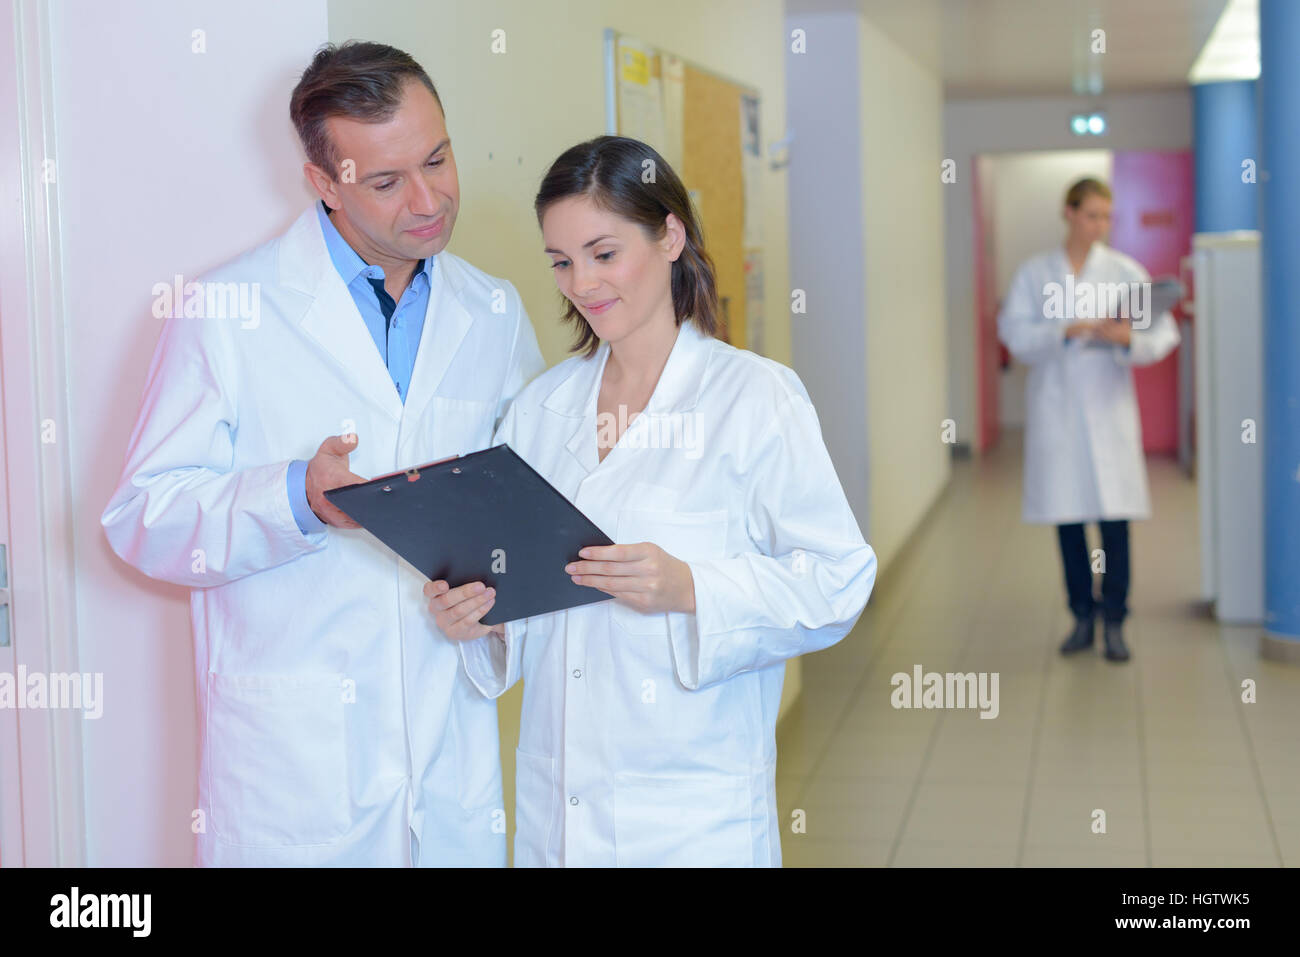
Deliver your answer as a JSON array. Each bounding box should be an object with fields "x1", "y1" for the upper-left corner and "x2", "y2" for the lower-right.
[{"x1": 308, "y1": 81, "x2": 460, "y2": 263}]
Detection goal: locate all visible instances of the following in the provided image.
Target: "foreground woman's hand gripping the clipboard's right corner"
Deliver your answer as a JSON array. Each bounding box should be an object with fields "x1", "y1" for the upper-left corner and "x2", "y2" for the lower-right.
[{"x1": 564, "y1": 542, "x2": 696, "y2": 614}]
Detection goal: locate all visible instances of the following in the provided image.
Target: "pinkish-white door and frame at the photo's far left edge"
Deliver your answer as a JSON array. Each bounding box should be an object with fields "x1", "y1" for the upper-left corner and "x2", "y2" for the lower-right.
[{"x1": 0, "y1": 0, "x2": 85, "y2": 867}]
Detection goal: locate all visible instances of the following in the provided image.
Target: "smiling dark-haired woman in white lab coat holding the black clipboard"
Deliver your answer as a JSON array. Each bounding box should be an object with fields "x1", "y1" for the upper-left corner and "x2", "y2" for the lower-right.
[{"x1": 425, "y1": 137, "x2": 876, "y2": 866}]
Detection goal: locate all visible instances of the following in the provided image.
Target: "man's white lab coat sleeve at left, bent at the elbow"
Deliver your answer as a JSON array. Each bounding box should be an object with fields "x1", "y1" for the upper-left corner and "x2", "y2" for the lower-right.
[{"x1": 100, "y1": 310, "x2": 326, "y2": 588}]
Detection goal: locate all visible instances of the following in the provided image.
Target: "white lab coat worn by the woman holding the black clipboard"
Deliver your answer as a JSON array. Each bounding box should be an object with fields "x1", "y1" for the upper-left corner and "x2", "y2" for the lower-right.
[{"x1": 462, "y1": 322, "x2": 876, "y2": 866}]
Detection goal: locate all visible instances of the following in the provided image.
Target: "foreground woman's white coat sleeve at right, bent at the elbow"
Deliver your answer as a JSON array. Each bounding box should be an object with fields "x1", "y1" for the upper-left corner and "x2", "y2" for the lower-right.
[{"x1": 668, "y1": 394, "x2": 876, "y2": 690}]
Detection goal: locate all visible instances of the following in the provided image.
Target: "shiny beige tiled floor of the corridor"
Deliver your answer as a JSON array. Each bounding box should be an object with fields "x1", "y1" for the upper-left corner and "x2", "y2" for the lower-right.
[{"x1": 777, "y1": 437, "x2": 1300, "y2": 867}]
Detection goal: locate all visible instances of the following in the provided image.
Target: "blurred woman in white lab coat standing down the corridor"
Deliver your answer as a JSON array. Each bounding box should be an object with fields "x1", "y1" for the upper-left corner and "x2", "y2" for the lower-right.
[{"x1": 997, "y1": 178, "x2": 1179, "y2": 662}]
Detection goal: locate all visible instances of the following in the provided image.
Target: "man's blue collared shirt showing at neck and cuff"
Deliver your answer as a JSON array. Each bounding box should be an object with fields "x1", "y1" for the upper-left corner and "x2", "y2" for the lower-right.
[{"x1": 285, "y1": 203, "x2": 434, "y2": 534}]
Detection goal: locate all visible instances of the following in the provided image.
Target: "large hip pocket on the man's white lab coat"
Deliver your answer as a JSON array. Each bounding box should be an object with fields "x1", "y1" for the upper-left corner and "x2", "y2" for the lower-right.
[{"x1": 207, "y1": 674, "x2": 348, "y2": 848}]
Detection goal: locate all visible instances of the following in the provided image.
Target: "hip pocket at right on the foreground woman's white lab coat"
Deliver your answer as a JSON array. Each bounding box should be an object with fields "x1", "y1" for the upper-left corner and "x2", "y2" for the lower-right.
[{"x1": 614, "y1": 771, "x2": 754, "y2": 867}]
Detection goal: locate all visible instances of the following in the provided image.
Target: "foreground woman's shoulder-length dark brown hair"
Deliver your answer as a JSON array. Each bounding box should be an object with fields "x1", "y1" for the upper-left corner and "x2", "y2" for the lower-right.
[{"x1": 533, "y1": 137, "x2": 718, "y2": 356}]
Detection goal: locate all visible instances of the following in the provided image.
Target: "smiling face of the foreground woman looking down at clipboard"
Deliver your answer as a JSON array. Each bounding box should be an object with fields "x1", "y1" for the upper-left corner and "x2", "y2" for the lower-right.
[{"x1": 542, "y1": 195, "x2": 685, "y2": 343}]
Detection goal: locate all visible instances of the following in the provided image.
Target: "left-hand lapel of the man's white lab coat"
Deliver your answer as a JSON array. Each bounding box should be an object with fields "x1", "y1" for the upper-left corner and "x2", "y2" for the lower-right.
[{"x1": 280, "y1": 205, "x2": 402, "y2": 420}]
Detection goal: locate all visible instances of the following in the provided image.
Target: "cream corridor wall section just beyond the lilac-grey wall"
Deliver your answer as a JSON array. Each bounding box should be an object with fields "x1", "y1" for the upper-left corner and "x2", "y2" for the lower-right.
[{"x1": 858, "y1": 18, "x2": 962, "y2": 567}]
